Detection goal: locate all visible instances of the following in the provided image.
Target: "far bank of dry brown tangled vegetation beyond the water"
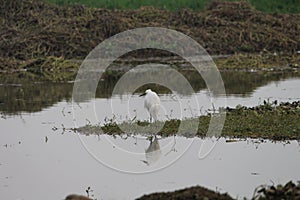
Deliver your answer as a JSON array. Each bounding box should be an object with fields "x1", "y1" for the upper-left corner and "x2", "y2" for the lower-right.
[{"x1": 0, "y1": 0, "x2": 300, "y2": 81}]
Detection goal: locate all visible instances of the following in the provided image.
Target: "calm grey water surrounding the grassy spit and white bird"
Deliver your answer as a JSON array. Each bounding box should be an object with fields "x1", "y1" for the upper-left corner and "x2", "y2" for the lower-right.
[{"x1": 0, "y1": 73, "x2": 300, "y2": 200}]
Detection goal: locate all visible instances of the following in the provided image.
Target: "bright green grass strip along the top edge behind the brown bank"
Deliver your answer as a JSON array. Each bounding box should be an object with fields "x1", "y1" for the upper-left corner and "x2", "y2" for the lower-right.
[{"x1": 48, "y1": 0, "x2": 300, "y2": 13}]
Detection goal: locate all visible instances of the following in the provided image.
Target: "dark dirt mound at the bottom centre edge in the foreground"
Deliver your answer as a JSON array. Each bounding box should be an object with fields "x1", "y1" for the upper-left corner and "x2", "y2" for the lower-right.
[{"x1": 137, "y1": 186, "x2": 232, "y2": 200}]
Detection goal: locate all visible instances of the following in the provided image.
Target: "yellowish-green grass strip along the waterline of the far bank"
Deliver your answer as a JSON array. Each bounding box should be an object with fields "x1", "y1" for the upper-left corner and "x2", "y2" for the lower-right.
[{"x1": 0, "y1": 54, "x2": 300, "y2": 82}]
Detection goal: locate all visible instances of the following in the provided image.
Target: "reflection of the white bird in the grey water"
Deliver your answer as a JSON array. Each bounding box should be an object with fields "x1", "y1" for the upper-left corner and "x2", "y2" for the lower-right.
[{"x1": 143, "y1": 136, "x2": 161, "y2": 165}]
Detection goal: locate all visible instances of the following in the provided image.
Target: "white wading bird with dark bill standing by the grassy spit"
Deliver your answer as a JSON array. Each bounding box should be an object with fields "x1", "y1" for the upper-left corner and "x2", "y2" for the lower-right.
[{"x1": 140, "y1": 89, "x2": 160, "y2": 122}]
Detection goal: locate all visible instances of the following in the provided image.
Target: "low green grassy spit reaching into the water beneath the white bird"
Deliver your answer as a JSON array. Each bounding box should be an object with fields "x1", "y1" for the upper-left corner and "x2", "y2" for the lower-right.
[{"x1": 76, "y1": 101, "x2": 300, "y2": 140}]
